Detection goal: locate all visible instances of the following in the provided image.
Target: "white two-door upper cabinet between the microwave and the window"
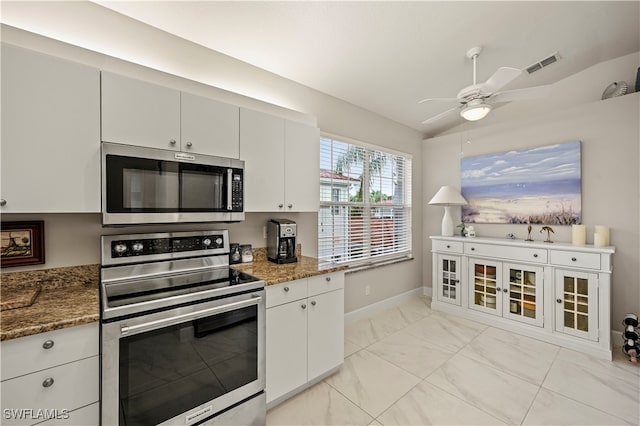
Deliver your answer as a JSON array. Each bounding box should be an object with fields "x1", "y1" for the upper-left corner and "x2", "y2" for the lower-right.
[{"x1": 240, "y1": 108, "x2": 320, "y2": 212}]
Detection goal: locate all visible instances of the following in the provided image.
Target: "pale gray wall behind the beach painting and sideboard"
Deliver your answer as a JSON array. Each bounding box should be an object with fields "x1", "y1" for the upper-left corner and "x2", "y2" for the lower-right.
[{"x1": 422, "y1": 91, "x2": 640, "y2": 329}]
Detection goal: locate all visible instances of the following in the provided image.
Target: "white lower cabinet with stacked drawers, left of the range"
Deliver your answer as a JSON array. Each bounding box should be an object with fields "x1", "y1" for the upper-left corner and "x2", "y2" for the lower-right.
[{"x1": 0, "y1": 322, "x2": 100, "y2": 425}]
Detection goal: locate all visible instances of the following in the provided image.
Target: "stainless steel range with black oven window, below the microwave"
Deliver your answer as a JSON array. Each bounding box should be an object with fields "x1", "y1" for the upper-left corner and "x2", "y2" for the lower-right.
[{"x1": 100, "y1": 231, "x2": 266, "y2": 426}]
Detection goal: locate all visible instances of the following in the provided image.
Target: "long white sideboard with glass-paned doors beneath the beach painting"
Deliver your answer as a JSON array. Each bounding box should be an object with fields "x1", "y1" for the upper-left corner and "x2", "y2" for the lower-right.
[{"x1": 431, "y1": 236, "x2": 615, "y2": 359}]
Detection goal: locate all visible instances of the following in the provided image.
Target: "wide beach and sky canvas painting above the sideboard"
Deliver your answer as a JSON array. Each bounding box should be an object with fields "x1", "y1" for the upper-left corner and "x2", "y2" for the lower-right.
[{"x1": 460, "y1": 141, "x2": 582, "y2": 225}]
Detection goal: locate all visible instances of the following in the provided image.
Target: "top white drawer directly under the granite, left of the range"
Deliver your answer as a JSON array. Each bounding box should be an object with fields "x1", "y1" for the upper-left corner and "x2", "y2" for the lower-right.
[{"x1": 0, "y1": 322, "x2": 99, "y2": 380}]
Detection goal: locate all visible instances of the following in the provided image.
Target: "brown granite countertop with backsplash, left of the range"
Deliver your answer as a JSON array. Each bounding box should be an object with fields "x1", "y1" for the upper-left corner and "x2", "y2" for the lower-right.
[{"x1": 0, "y1": 265, "x2": 100, "y2": 341}]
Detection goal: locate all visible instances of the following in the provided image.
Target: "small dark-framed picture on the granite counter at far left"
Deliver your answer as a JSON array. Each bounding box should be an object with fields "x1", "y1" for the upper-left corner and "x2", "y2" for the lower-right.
[{"x1": 0, "y1": 220, "x2": 44, "y2": 268}]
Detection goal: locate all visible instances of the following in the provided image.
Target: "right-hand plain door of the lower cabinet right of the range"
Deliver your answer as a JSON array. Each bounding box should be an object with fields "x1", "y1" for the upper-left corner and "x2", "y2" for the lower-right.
[{"x1": 307, "y1": 289, "x2": 344, "y2": 380}]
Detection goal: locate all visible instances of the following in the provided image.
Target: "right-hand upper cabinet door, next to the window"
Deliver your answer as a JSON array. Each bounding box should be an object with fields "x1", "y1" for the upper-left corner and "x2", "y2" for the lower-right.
[{"x1": 284, "y1": 120, "x2": 320, "y2": 212}]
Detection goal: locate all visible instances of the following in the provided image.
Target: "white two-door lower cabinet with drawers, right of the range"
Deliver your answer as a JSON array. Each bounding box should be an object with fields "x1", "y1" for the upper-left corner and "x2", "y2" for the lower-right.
[{"x1": 266, "y1": 272, "x2": 344, "y2": 406}]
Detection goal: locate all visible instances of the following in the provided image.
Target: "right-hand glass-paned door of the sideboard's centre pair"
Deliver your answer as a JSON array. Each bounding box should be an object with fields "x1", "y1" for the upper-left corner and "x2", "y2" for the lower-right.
[{"x1": 502, "y1": 263, "x2": 544, "y2": 327}]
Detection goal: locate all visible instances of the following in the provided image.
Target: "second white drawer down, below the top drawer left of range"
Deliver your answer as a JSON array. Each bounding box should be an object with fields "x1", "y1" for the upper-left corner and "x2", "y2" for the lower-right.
[{"x1": 2, "y1": 356, "x2": 100, "y2": 425}]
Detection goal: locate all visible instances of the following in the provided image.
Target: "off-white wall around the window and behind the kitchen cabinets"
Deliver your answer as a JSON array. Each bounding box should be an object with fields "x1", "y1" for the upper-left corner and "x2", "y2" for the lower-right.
[{"x1": 1, "y1": 2, "x2": 423, "y2": 312}]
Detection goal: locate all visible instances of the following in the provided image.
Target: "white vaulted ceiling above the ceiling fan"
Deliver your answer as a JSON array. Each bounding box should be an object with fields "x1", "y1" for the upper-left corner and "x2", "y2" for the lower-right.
[{"x1": 17, "y1": 0, "x2": 640, "y2": 133}]
